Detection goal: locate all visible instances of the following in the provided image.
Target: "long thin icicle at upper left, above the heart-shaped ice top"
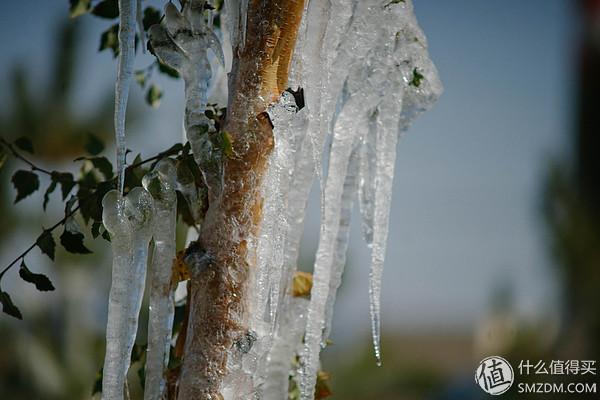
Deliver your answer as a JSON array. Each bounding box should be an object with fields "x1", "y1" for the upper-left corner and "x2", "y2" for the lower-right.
[{"x1": 114, "y1": 0, "x2": 137, "y2": 193}]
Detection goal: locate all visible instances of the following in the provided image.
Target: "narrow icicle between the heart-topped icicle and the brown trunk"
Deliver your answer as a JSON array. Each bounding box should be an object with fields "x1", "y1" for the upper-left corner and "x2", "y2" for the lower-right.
[{"x1": 142, "y1": 159, "x2": 177, "y2": 400}]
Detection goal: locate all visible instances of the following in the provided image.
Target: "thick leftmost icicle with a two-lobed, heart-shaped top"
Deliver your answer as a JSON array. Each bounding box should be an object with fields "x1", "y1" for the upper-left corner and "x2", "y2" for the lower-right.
[{"x1": 102, "y1": 187, "x2": 154, "y2": 400}]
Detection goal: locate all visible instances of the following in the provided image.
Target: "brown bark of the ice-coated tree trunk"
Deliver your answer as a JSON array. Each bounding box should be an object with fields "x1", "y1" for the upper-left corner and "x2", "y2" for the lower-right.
[{"x1": 179, "y1": 0, "x2": 304, "y2": 400}]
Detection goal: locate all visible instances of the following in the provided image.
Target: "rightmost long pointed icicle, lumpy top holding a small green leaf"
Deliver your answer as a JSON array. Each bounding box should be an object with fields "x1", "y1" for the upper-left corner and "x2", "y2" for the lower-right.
[{"x1": 359, "y1": 1, "x2": 442, "y2": 365}]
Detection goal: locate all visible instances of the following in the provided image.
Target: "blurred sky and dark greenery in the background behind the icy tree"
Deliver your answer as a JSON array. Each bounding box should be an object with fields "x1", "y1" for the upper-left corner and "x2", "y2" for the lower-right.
[{"x1": 0, "y1": 0, "x2": 600, "y2": 400}]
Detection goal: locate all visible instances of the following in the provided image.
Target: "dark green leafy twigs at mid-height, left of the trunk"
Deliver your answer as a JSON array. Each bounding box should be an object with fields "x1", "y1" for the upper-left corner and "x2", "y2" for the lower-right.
[{"x1": 0, "y1": 131, "x2": 207, "y2": 318}]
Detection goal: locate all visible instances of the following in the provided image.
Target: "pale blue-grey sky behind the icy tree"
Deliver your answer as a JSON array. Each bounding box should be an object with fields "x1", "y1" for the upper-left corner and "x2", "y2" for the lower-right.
[{"x1": 0, "y1": 0, "x2": 577, "y2": 337}]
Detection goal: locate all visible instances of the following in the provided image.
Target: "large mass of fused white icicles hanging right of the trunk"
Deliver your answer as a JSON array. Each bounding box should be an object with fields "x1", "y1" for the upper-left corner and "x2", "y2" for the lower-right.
[{"x1": 257, "y1": 0, "x2": 442, "y2": 399}]
